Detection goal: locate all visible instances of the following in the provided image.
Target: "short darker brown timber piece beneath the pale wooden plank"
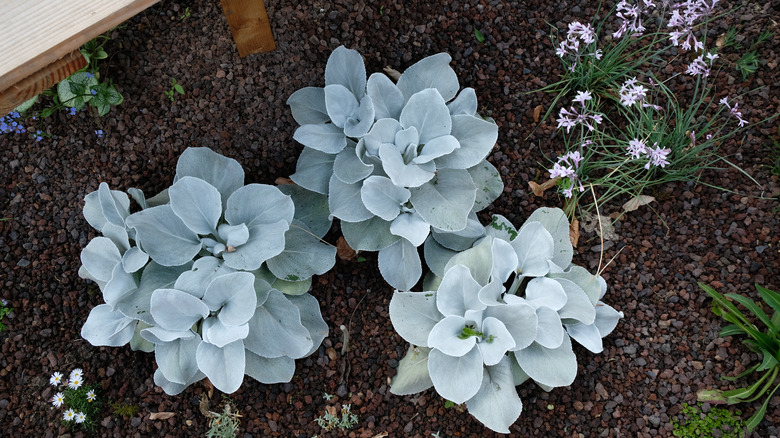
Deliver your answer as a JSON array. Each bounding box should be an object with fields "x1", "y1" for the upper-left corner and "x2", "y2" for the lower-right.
[{"x1": 0, "y1": 50, "x2": 87, "y2": 116}]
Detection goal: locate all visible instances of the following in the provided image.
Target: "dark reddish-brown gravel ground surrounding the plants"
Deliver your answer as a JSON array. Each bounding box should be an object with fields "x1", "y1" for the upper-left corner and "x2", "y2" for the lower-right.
[{"x1": 0, "y1": 0, "x2": 780, "y2": 438}]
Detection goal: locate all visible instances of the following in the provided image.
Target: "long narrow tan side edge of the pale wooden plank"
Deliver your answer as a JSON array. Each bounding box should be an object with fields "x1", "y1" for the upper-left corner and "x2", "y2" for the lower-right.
[{"x1": 0, "y1": 0, "x2": 160, "y2": 93}]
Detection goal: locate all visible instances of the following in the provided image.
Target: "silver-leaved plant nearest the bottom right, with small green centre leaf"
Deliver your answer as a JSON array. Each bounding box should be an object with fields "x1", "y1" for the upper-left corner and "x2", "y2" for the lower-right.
[{"x1": 390, "y1": 208, "x2": 623, "y2": 433}]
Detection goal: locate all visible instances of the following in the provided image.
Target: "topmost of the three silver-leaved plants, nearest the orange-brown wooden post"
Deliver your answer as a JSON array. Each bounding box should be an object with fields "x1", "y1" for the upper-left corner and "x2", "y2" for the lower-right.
[{"x1": 287, "y1": 47, "x2": 503, "y2": 290}]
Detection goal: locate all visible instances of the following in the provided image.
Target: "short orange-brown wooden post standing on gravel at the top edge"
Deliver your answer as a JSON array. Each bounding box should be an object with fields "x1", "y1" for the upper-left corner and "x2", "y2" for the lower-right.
[{"x1": 220, "y1": 0, "x2": 276, "y2": 58}]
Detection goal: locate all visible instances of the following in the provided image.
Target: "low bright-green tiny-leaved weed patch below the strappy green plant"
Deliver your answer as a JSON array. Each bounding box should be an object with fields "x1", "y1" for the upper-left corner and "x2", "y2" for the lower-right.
[{"x1": 672, "y1": 403, "x2": 745, "y2": 438}]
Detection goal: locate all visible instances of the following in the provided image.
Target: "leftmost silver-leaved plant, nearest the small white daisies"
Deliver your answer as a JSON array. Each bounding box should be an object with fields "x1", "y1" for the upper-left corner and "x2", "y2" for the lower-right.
[{"x1": 79, "y1": 148, "x2": 336, "y2": 394}]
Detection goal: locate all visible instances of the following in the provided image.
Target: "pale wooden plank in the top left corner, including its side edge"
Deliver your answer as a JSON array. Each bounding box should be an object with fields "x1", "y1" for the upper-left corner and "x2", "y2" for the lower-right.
[{"x1": 0, "y1": 0, "x2": 159, "y2": 92}]
